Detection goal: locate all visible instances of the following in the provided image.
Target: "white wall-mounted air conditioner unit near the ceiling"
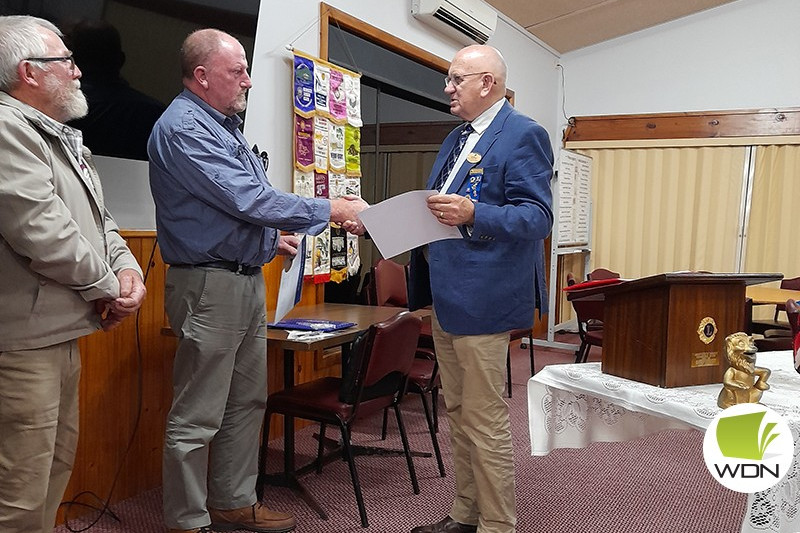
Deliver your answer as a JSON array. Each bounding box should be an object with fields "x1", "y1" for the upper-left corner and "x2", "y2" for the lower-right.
[{"x1": 411, "y1": 0, "x2": 497, "y2": 44}]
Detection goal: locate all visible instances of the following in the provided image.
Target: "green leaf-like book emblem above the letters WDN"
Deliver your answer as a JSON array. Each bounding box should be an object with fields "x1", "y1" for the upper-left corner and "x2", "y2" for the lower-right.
[{"x1": 717, "y1": 411, "x2": 780, "y2": 461}]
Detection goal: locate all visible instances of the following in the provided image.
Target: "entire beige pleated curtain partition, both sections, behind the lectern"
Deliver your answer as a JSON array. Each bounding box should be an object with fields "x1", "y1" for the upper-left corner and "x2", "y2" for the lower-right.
[{"x1": 558, "y1": 140, "x2": 800, "y2": 321}]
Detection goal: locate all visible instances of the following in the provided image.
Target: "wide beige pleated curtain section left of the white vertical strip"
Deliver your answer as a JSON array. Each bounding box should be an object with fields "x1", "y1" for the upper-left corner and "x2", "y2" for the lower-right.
[{"x1": 581, "y1": 146, "x2": 747, "y2": 278}]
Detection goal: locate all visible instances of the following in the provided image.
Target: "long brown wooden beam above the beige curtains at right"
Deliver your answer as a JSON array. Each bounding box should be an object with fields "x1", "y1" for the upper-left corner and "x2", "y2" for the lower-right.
[{"x1": 563, "y1": 108, "x2": 800, "y2": 143}]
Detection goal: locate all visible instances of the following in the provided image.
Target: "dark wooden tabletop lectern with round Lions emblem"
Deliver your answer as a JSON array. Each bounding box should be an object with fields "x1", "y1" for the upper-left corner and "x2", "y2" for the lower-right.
[{"x1": 567, "y1": 272, "x2": 783, "y2": 387}]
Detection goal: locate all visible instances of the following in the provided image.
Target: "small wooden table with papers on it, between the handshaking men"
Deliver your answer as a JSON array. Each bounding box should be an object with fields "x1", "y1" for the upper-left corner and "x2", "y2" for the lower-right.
[{"x1": 257, "y1": 303, "x2": 430, "y2": 519}]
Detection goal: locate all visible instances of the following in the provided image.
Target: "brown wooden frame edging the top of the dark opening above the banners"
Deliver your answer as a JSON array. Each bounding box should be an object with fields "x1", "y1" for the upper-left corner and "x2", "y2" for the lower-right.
[{"x1": 319, "y1": 2, "x2": 450, "y2": 73}]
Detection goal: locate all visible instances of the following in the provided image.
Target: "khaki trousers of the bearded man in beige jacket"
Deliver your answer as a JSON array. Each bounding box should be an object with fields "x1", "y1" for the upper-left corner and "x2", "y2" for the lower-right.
[{"x1": 0, "y1": 341, "x2": 81, "y2": 533}]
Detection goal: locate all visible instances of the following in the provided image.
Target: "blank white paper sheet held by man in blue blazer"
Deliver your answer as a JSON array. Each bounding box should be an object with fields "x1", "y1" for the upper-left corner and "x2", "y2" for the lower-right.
[{"x1": 358, "y1": 190, "x2": 461, "y2": 259}]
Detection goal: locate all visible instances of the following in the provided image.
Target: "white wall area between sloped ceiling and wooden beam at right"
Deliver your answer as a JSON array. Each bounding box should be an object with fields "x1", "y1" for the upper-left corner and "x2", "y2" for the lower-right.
[{"x1": 557, "y1": 0, "x2": 800, "y2": 117}]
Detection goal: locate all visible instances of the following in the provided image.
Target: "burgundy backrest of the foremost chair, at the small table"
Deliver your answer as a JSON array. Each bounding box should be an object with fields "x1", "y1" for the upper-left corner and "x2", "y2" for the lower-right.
[{"x1": 339, "y1": 311, "x2": 422, "y2": 406}]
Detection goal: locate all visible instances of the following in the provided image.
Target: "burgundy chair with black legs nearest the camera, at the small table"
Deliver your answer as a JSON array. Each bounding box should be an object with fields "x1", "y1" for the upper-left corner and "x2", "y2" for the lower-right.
[{"x1": 259, "y1": 311, "x2": 422, "y2": 527}]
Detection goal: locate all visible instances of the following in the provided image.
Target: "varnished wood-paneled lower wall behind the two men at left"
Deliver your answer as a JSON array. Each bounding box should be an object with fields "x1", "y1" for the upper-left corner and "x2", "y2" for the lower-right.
[{"x1": 58, "y1": 231, "x2": 332, "y2": 523}]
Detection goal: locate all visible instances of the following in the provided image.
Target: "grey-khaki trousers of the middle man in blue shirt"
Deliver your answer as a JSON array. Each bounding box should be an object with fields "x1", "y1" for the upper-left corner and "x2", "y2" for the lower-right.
[{"x1": 162, "y1": 267, "x2": 267, "y2": 529}]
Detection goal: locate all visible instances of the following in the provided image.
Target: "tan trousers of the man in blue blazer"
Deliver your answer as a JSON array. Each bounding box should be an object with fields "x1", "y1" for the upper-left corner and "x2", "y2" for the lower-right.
[{"x1": 432, "y1": 313, "x2": 517, "y2": 533}]
